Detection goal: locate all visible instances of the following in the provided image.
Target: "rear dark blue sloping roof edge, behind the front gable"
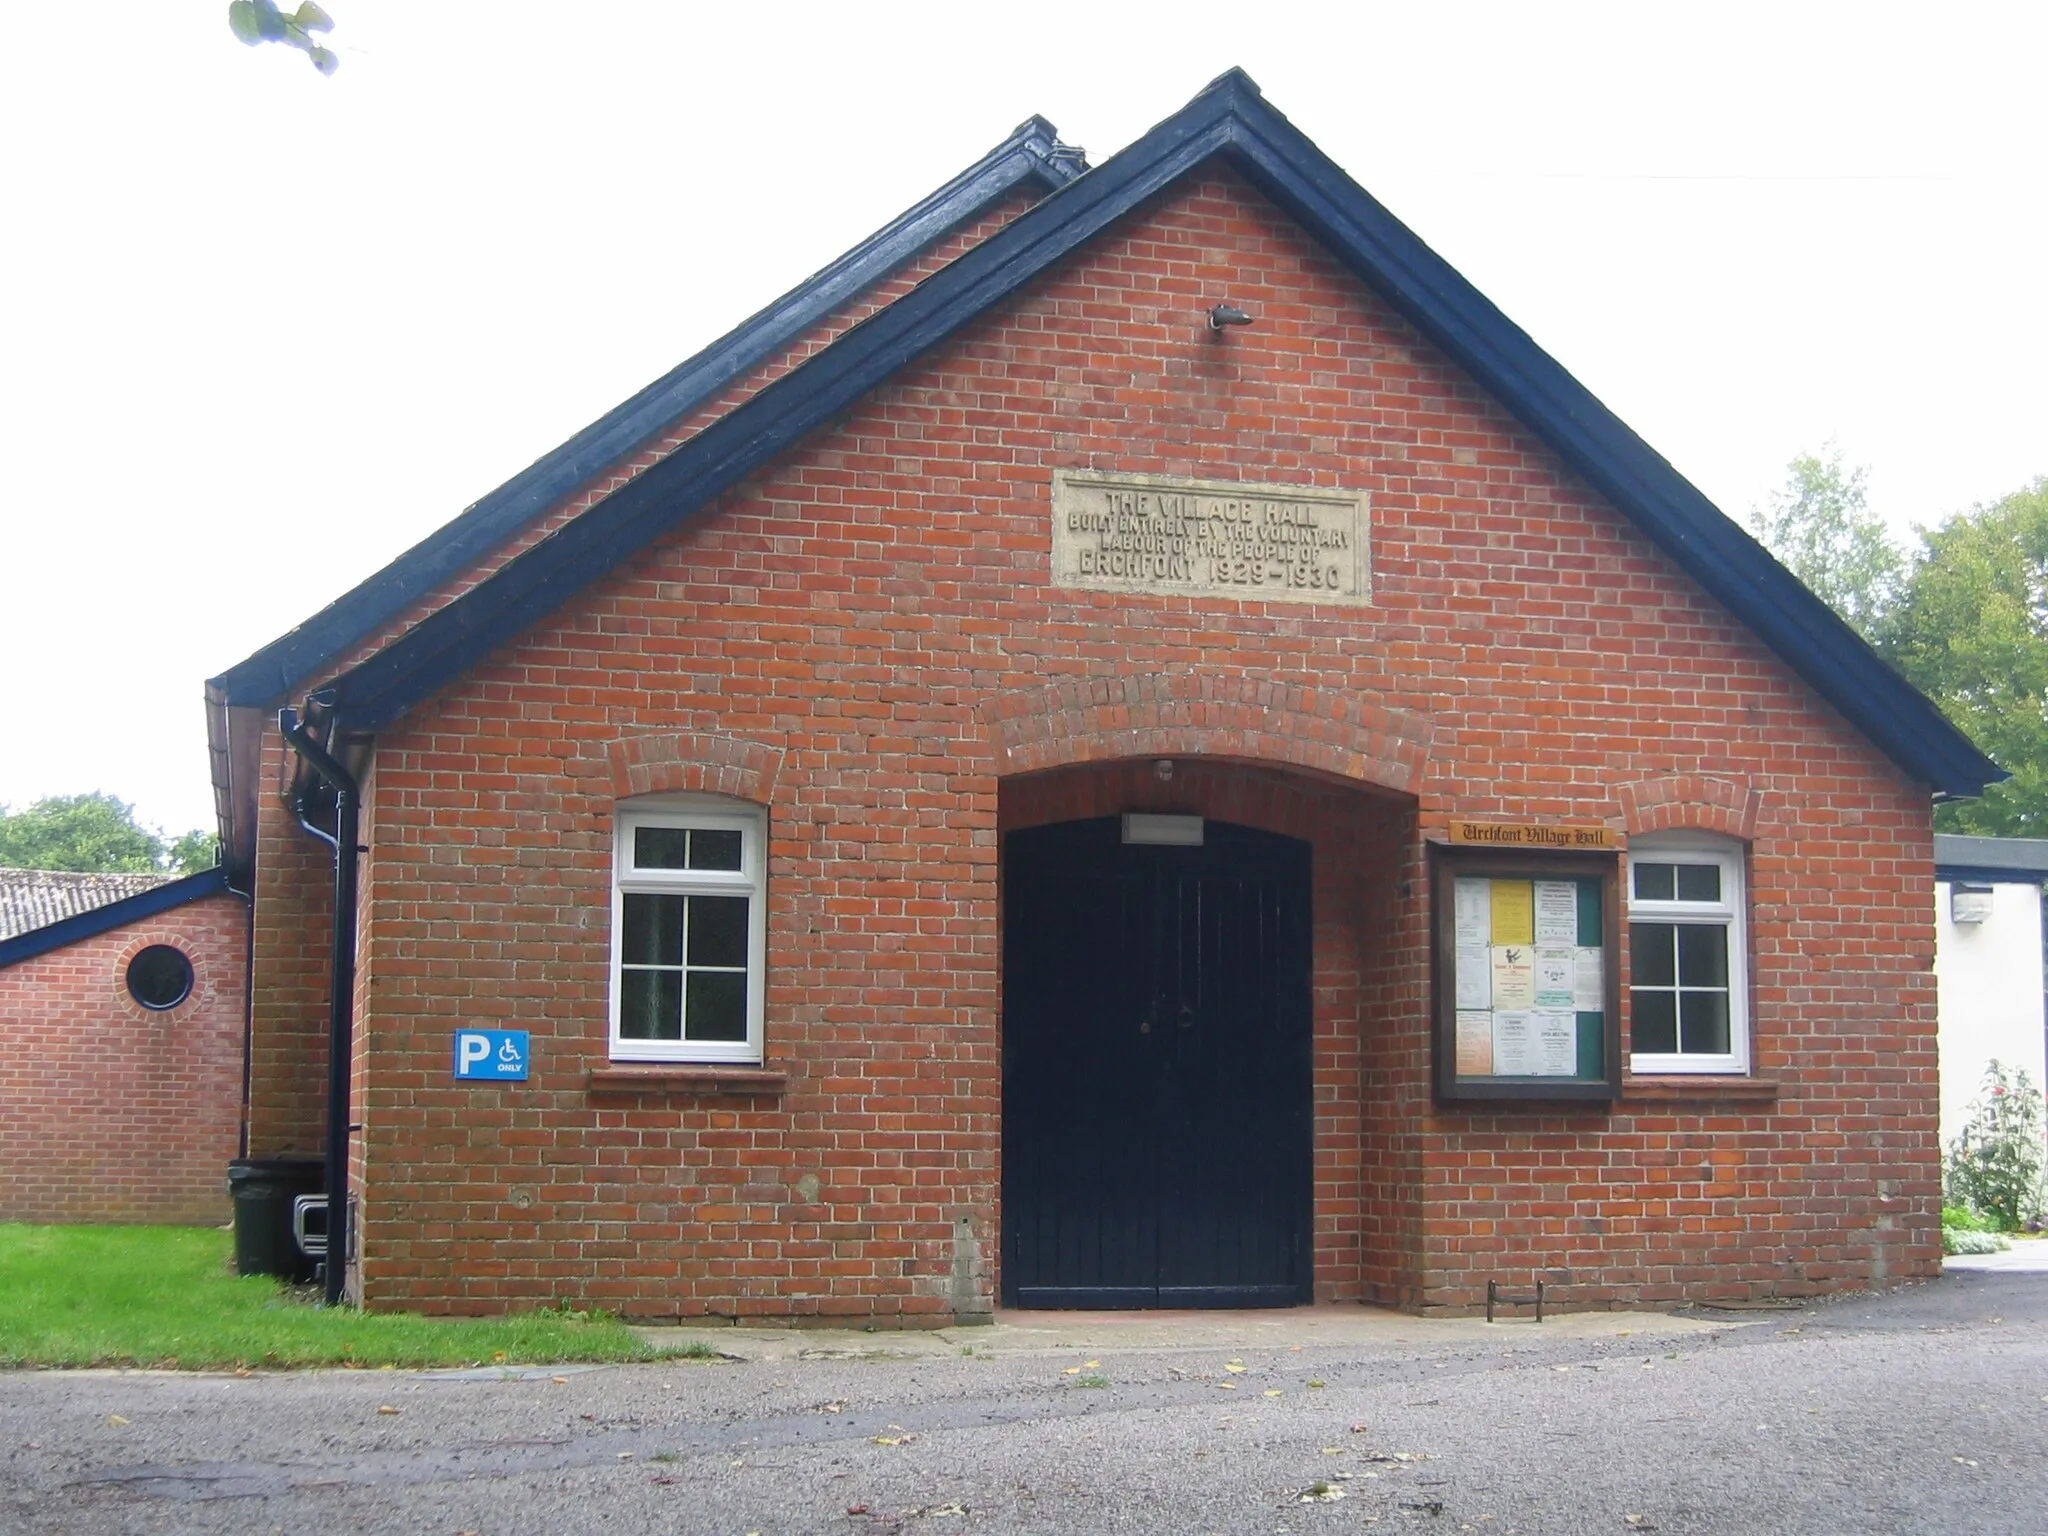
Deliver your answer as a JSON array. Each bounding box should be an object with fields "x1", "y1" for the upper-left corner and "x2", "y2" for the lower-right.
[{"x1": 207, "y1": 117, "x2": 1087, "y2": 707}]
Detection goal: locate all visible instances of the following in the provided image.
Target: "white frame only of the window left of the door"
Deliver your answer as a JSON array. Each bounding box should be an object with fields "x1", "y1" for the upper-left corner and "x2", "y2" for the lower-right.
[{"x1": 610, "y1": 795, "x2": 768, "y2": 1065}]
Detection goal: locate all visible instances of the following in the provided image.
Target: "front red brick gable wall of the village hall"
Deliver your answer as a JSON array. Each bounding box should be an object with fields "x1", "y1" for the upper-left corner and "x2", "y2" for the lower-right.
[{"x1": 260, "y1": 174, "x2": 1937, "y2": 1321}]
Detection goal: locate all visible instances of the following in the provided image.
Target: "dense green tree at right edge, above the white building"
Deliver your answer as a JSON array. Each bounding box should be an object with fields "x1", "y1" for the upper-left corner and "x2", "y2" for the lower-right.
[{"x1": 1884, "y1": 477, "x2": 2048, "y2": 838}]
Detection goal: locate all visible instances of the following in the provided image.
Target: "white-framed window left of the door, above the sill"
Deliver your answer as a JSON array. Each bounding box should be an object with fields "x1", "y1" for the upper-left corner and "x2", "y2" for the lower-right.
[{"x1": 612, "y1": 795, "x2": 768, "y2": 1063}]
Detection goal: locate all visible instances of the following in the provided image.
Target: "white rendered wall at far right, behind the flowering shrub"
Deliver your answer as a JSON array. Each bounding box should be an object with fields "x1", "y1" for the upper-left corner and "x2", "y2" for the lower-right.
[{"x1": 1933, "y1": 881, "x2": 2048, "y2": 1151}]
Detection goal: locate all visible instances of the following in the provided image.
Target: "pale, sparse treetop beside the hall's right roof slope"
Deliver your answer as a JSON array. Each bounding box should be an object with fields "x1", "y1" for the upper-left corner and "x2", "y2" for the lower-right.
[{"x1": 1749, "y1": 446, "x2": 1907, "y2": 641}]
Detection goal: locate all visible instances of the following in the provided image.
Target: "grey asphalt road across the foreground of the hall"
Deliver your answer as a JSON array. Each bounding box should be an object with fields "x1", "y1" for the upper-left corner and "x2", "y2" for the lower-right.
[{"x1": 0, "y1": 1270, "x2": 2048, "y2": 1536}]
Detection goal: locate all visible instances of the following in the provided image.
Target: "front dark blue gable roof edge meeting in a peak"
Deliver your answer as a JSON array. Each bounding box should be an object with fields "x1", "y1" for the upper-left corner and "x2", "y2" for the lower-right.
[{"x1": 299, "y1": 70, "x2": 2007, "y2": 795}]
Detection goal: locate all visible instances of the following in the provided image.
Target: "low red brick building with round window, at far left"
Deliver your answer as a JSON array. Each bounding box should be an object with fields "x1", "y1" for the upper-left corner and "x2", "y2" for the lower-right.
[{"x1": 0, "y1": 870, "x2": 250, "y2": 1225}]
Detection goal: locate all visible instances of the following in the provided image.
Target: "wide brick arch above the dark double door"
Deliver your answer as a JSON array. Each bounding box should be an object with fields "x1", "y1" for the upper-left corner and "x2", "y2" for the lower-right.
[{"x1": 983, "y1": 672, "x2": 1432, "y2": 795}]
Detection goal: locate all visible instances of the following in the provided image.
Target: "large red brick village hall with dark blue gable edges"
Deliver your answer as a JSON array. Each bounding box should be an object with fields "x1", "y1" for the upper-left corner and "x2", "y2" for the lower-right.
[{"x1": 209, "y1": 74, "x2": 1999, "y2": 1323}]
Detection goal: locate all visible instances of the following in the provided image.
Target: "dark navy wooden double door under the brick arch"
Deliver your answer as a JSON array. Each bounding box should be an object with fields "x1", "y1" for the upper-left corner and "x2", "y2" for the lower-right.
[{"x1": 1004, "y1": 817, "x2": 1313, "y2": 1307}]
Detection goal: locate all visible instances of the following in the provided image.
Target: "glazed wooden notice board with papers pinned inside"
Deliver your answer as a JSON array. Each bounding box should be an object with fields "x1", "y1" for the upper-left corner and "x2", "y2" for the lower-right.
[{"x1": 1430, "y1": 846, "x2": 1622, "y2": 1102}]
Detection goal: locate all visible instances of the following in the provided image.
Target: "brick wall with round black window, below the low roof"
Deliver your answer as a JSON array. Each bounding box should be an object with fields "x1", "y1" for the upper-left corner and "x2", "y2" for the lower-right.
[{"x1": 0, "y1": 895, "x2": 248, "y2": 1225}]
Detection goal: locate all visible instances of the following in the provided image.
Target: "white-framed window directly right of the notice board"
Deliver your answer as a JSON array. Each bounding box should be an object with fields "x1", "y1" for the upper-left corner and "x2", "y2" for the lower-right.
[{"x1": 1628, "y1": 834, "x2": 1749, "y2": 1073}]
